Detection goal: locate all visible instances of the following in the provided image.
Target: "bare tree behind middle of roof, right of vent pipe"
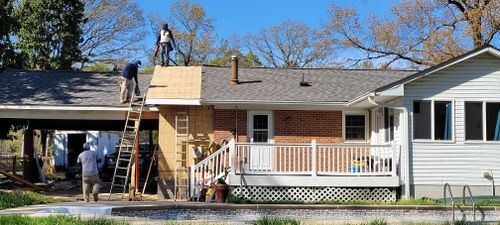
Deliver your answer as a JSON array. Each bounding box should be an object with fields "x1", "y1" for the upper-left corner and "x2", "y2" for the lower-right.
[{"x1": 245, "y1": 20, "x2": 333, "y2": 68}]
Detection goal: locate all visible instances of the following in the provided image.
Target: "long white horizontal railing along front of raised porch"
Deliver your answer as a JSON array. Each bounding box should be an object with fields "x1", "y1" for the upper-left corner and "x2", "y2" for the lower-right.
[{"x1": 230, "y1": 141, "x2": 400, "y2": 176}]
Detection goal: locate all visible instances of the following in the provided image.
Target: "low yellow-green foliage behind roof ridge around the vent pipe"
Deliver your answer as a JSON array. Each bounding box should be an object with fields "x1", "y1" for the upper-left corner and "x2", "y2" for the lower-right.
[{"x1": 209, "y1": 49, "x2": 262, "y2": 67}]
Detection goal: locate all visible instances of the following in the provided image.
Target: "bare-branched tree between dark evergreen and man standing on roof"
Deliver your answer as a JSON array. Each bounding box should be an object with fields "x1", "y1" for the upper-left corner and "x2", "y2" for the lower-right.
[{"x1": 79, "y1": 0, "x2": 145, "y2": 68}]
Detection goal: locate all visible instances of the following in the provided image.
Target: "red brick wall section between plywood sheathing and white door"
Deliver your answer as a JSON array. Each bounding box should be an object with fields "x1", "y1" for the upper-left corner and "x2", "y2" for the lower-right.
[{"x1": 214, "y1": 109, "x2": 248, "y2": 144}]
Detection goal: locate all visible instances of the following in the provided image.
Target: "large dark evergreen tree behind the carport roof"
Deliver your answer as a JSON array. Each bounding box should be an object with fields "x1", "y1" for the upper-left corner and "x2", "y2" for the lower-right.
[{"x1": 14, "y1": 0, "x2": 84, "y2": 69}]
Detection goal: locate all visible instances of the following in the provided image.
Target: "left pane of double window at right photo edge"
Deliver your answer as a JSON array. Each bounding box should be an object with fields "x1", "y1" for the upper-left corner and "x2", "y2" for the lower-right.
[{"x1": 465, "y1": 102, "x2": 483, "y2": 140}]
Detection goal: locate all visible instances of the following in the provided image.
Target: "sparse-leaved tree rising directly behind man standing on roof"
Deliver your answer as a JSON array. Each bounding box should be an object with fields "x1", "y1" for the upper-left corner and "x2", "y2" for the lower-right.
[{"x1": 149, "y1": 0, "x2": 217, "y2": 66}]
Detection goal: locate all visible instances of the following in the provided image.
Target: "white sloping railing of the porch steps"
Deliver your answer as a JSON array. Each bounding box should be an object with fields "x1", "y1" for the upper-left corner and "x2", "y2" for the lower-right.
[{"x1": 190, "y1": 139, "x2": 235, "y2": 197}]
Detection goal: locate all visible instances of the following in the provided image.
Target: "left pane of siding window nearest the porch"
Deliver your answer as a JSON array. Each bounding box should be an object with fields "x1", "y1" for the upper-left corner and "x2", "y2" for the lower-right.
[{"x1": 413, "y1": 101, "x2": 431, "y2": 139}]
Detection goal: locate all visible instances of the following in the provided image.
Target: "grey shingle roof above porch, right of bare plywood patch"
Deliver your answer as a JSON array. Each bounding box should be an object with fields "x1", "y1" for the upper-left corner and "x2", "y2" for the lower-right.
[{"x1": 201, "y1": 66, "x2": 416, "y2": 102}]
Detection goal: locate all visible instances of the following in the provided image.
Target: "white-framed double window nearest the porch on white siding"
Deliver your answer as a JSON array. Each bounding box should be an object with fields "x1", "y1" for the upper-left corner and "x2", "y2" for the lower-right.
[{"x1": 413, "y1": 101, "x2": 453, "y2": 140}]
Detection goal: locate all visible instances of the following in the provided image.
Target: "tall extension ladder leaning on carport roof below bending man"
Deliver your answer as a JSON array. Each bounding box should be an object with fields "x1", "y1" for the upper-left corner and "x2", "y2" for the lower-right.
[{"x1": 108, "y1": 94, "x2": 146, "y2": 200}]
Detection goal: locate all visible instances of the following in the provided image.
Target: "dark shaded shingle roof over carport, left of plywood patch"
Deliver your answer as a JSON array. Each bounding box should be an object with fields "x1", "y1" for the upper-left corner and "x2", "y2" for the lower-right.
[{"x1": 0, "y1": 69, "x2": 152, "y2": 107}]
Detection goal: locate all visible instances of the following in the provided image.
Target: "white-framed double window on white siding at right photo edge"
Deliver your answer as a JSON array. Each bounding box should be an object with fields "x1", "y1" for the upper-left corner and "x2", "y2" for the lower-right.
[{"x1": 465, "y1": 102, "x2": 500, "y2": 141}]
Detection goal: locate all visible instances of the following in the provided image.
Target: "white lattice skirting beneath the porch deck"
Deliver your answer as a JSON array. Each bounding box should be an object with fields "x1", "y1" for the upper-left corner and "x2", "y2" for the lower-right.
[{"x1": 231, "y1": 186, "x2": 396, "y2": 202}]
